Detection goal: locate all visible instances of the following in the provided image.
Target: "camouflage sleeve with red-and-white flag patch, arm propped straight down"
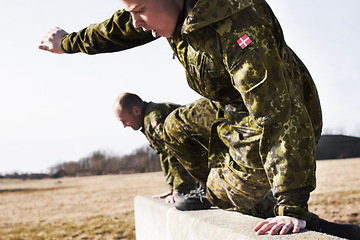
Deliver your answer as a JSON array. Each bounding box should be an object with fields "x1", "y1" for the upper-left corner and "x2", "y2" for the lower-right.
[{"x1": 219, "y1": 21, "x2": 315, "y2": 219}]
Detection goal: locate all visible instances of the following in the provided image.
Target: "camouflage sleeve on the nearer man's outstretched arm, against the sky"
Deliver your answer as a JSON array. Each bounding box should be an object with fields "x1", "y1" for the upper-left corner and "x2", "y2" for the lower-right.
[{"x1": 62, "y1": 10, "x2": 155, "y2": 54}]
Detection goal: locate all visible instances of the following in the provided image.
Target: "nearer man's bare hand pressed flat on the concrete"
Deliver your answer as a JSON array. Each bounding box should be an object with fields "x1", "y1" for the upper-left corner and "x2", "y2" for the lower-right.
[{"x1": 253, "y1": 216, "x2": 306, "y2": 235}]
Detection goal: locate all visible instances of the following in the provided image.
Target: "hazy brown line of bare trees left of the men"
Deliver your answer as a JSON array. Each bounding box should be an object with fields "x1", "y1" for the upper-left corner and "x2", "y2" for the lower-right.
[{"x1": 0, "y1": 146, "x2": 161, "y2": 179}]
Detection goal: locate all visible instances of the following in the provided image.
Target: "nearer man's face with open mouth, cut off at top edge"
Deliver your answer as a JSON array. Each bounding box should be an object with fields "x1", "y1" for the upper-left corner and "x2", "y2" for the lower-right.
[{"x1": 121, "y1": 0, "x2": 184, "y2": 37}]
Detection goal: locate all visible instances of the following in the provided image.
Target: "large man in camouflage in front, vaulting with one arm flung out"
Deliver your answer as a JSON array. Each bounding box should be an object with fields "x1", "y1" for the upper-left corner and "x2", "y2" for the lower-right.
[{"x1": 39, "y1": 0, "x2": 360, "y2": 236}]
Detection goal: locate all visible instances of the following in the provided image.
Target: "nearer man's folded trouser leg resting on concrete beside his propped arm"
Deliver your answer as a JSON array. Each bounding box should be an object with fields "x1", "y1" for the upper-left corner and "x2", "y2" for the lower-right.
[{"x1": 207, "y1": 166, "x2": 276, "y2": 218}]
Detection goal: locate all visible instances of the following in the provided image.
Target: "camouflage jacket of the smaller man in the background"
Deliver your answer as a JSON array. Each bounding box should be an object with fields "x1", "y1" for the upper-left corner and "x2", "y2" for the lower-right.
[{"x1": 141, "y1": 102, "x2": 196, "y2": 193}]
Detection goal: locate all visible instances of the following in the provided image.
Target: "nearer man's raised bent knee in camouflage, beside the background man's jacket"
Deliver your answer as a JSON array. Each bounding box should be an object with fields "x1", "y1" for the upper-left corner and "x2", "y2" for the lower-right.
[{"x1": 164, "y1": 99, "x2": 217, "y2": 186}]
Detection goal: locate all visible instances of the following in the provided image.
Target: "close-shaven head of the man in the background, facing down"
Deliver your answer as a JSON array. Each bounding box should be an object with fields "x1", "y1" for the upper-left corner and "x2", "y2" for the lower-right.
[{"x1": 113, "y1": 93, "x2": 144, "y2": 130}]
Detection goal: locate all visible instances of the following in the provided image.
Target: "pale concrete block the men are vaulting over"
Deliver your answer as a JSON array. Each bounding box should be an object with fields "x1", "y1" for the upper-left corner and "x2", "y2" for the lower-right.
[{"x1": 135, "y1": 196, "x2": 341, "y2": 240}]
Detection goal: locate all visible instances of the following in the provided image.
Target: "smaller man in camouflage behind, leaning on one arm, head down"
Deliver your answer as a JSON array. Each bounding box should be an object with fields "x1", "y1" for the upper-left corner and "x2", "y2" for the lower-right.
[{"x1": 114, "y1": 93, "x2": 200, "y2": 203}]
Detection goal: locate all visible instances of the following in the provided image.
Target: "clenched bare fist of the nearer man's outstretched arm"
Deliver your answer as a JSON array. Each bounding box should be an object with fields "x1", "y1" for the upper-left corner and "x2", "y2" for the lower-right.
[{"x1": 39, "y1": 27, "x2": 68, "y2": 54}]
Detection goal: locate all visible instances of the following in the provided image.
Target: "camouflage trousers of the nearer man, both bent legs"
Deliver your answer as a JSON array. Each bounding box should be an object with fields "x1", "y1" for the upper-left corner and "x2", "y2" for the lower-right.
[{"x1": 164, "y1": 99, "x2": 276, "y2": 218}]
